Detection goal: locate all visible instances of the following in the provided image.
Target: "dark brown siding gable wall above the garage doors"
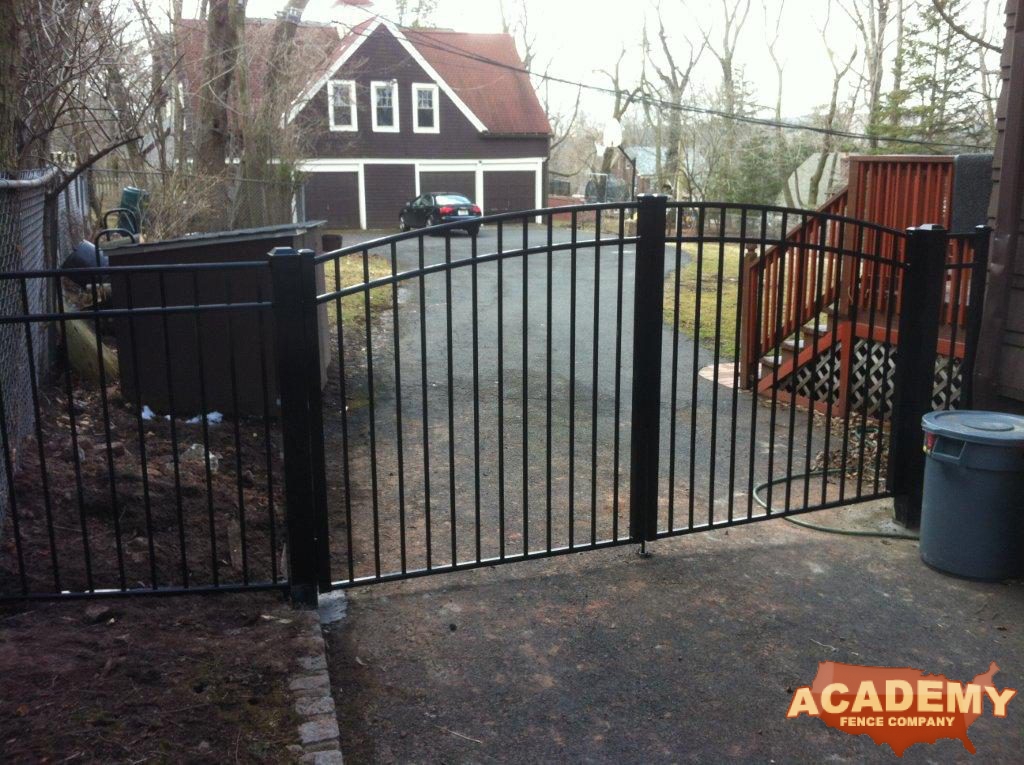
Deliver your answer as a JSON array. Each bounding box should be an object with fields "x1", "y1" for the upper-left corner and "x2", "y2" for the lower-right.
[{"x1": 297, "y1": 26, "x2": 548, "y2": 160}]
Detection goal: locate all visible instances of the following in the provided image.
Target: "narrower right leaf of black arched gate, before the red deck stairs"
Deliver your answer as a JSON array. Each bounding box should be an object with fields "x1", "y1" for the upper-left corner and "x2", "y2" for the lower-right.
[{"x1": 657, "y1": 203, "x2": 904, "y2": 537}]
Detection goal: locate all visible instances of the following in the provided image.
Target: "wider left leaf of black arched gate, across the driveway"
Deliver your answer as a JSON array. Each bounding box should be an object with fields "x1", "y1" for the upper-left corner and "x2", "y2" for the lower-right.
[{"x1": 317, "y1": 204, "x2": 637, "y2": 586}]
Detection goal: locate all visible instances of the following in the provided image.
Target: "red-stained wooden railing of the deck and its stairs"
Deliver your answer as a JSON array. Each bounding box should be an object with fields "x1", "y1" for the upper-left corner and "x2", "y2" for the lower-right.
[{"x1": 740, "y1": 156, "x2": 974, "y2": 395}]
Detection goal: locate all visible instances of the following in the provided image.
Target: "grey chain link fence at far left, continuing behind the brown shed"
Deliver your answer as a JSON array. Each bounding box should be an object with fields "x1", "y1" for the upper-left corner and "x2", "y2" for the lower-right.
[{"x1": 0, "y1": 168, "x2": 305, "y2": 543}]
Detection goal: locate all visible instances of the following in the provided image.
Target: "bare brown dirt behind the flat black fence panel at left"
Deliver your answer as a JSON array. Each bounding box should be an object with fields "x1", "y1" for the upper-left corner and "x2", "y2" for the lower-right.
[{"x1": 0, "y1": 380, "x2": 284, "y2": 595}]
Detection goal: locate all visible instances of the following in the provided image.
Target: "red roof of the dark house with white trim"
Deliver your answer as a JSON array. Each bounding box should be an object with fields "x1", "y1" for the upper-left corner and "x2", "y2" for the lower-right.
[{"x1": 177, "y1": 18, "x2": 551, "y2": 135}]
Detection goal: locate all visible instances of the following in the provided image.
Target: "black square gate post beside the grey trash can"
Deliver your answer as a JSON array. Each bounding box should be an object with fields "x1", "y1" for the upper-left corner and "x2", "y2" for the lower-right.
[{"x1": 887, "y1": 224, "x2": 948, "y2": 528}]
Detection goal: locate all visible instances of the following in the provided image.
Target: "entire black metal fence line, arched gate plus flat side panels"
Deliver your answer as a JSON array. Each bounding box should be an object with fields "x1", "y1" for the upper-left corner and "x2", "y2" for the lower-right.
[{"x1": 0, "y1": 197, "x2": 985, "y2": 602}]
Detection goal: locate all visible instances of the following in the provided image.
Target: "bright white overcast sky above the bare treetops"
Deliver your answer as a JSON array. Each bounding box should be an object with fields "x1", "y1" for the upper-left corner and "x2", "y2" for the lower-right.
[{"x1": 180, "y1": 0, "x2": 1002, "y2": 122}]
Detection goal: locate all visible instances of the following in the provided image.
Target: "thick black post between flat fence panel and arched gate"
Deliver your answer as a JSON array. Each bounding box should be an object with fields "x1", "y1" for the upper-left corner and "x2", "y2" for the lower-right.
[{"x1": 269, "y1": 247, "x2": 330, "y2": 608}]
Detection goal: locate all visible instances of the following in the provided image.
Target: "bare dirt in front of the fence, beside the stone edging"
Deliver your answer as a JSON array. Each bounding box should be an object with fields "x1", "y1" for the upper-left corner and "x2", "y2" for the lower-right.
[{"x1": 0, "y1": 594, "x2": 299, "y2": 763}]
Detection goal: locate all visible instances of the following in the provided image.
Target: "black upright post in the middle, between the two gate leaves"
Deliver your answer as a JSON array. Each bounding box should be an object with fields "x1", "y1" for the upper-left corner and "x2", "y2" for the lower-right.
[{"x1": 630, "y1": 194, "x2": 668, "y2": 542}]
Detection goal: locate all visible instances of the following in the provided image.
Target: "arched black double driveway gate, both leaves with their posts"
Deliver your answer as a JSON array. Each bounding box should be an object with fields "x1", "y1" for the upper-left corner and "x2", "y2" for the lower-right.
[{"x1": 272, "y1": 196, "x2": 983, "y2": 599}]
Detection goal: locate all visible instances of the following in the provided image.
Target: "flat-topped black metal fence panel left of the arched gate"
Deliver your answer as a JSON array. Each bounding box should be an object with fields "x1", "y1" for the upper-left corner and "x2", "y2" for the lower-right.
[{"x1": 0, "y1": 262, "x2": 286, "y2": 597}]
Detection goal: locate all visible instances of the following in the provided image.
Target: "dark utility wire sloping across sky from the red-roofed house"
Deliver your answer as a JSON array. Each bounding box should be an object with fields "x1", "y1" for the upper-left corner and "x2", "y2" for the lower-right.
[{"x1": 336, "y1": 11, "x2": 990, "y2": 151}]
